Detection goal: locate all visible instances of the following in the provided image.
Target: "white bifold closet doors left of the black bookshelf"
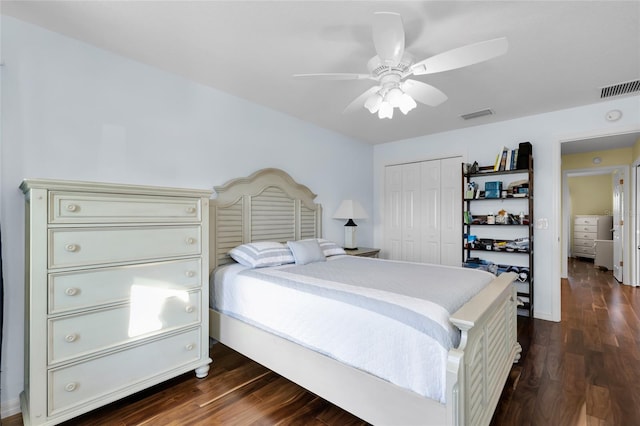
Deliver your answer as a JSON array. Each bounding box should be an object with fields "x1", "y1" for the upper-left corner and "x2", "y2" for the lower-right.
[{"x1": 383, "y1": 157, "x2": 462, "y2": 266}]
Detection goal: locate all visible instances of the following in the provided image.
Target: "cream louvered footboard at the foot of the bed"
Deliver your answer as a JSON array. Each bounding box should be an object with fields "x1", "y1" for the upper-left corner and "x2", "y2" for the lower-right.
[{"x1": 447, "y1": 273, "x2": 522, "y2": 425}]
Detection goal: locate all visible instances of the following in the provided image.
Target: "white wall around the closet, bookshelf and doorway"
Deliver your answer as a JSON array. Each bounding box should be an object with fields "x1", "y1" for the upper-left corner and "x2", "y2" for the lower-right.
[{"x1": 373, "y1": 95, "x2": 640, "y2": 321}]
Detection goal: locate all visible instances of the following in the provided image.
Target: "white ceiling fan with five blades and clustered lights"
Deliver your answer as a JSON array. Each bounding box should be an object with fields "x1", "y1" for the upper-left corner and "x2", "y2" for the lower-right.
[{"x1": 294, "y1": 12, "x2": 508, "y2": 118}]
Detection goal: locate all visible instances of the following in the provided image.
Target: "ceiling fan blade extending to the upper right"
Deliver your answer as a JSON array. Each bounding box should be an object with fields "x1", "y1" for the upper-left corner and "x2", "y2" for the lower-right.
[{"x1": 411, "y1": 37, "x2": 509, "y2": 75}]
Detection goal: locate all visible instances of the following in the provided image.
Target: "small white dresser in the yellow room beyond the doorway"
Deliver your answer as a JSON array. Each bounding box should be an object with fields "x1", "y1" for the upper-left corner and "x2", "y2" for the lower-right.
[{"x1": 571, "y1": 215, "x2": 613, "y2": 259}]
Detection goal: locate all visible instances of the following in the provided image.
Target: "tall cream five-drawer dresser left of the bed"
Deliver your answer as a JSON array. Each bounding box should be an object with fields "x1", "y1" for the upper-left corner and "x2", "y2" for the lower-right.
[{"x1": 20, "y1": 179, "x2": 211, "y2": 425}]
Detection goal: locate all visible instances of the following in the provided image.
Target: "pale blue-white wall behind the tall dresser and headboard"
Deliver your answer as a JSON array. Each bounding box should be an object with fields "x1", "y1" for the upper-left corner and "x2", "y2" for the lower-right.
[{"x1": 0, "y1": 16, "x2": 373, "y2": 417}]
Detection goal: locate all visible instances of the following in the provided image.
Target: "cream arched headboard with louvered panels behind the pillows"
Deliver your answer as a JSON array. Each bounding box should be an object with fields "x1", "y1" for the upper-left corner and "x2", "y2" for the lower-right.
[{"x1": 209, "y1": 168, "x2": 322, "y2": 270}]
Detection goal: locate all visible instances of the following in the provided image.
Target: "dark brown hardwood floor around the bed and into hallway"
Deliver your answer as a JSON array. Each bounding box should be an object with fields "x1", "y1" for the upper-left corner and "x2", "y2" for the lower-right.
[{"x1": 2, "y1": 260, "x2": 640, "y2": 426}]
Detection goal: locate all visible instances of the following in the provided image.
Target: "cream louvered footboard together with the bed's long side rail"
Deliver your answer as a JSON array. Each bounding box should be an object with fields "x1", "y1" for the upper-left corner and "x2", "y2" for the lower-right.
[{"x1": 209, "y1": 273, "x2": 522, "y2": 426}]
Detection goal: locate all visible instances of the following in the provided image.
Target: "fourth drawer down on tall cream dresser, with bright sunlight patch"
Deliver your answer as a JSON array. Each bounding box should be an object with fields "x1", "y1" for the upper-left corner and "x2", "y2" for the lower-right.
[{"x1": 49, "y1": 292, "x2": 201, "y2": 364}]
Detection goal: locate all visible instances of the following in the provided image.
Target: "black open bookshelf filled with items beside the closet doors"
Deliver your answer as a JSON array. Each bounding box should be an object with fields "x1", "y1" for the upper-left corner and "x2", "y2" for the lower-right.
[{"x1": 462, "y1": 155, "x2": 535, "y2": 318}]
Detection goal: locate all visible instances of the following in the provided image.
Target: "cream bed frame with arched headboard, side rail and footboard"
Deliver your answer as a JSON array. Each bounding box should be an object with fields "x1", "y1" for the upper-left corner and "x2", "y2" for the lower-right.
[{"x1": 209, "y1": 169, "x2": 522, "y2": 426}]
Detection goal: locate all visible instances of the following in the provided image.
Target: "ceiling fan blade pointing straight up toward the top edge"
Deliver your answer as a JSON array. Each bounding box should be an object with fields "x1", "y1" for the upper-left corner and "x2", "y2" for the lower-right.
[{"x1": 372, "y1": 12, "x2": 404, "y2": 66}]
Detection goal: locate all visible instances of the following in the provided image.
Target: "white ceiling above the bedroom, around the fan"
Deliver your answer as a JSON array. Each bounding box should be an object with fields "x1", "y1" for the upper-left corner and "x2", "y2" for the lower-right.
[{"x1": 1, "y1": 0, "x2": 640, "y2": 144}]
